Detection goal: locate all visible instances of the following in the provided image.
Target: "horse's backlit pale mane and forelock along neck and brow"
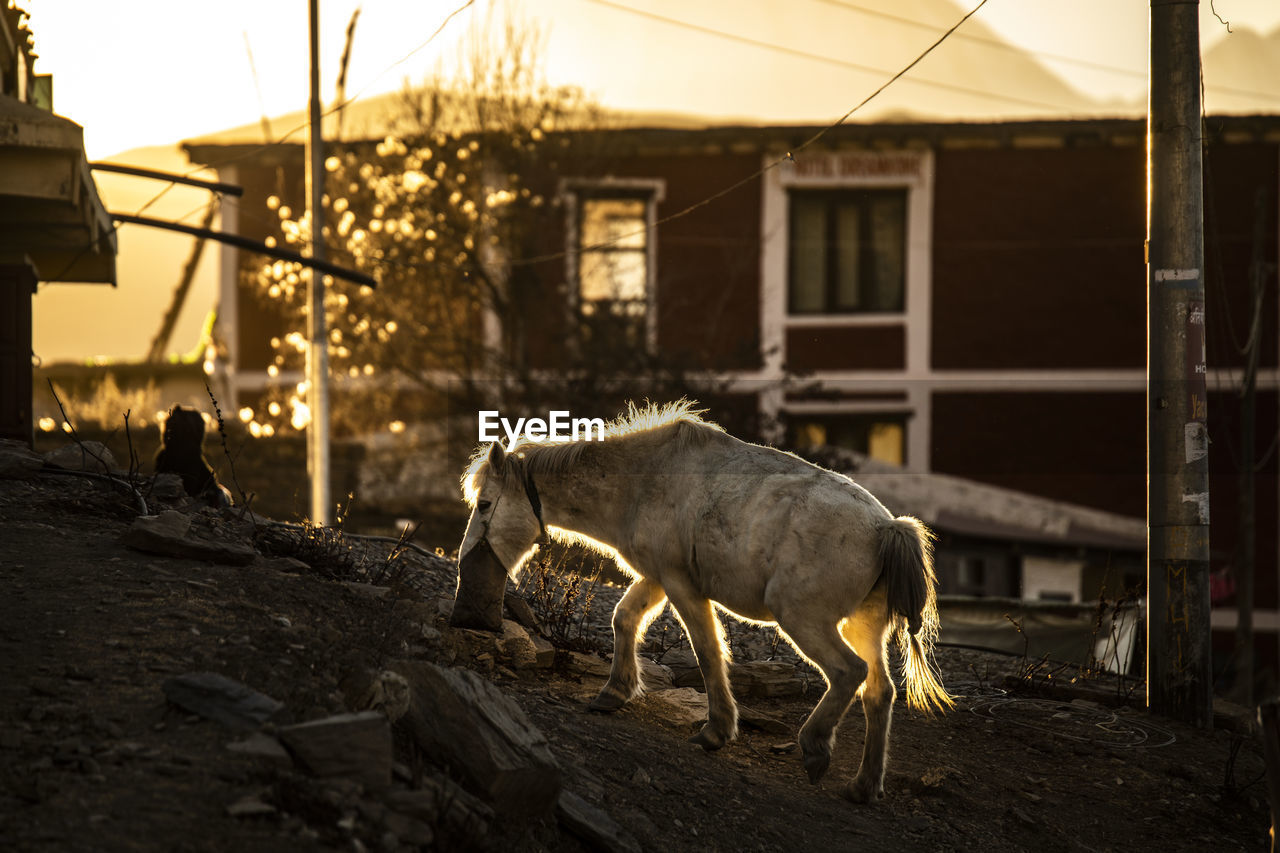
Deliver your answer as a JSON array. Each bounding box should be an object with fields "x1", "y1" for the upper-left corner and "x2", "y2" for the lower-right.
[{"x1": 462, "y1": 400, "x2": 724, "y2": 507}]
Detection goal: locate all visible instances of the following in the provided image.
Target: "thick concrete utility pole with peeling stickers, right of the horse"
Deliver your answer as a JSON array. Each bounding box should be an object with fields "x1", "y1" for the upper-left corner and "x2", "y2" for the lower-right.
[{"x1": 1147, "y1": 0, "x2": 1213, "y2": 727}]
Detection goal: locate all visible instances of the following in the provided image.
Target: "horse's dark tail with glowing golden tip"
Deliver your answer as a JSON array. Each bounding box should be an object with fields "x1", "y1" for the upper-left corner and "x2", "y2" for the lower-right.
[{"x1": 879, "y1": 516, "x2": 955, "y2": 713}]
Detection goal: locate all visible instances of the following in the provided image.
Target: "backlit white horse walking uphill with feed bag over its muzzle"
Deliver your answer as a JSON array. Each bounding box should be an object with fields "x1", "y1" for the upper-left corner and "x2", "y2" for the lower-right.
[{"x1": 452, "y1": 401, "x2": 951, "y2": 802}]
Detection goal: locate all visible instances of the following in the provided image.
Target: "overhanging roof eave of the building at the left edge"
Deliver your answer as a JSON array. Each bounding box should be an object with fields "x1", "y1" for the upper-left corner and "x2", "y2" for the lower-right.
[{"x1": 0, "y1": 95, "x2": 116, "y2": 286}]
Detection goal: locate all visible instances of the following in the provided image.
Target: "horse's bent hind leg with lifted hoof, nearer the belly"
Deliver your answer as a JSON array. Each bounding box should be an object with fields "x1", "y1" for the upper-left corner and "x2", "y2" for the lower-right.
[{"x1": 774, "y1": 608, "x2": 867, "y2": 783}]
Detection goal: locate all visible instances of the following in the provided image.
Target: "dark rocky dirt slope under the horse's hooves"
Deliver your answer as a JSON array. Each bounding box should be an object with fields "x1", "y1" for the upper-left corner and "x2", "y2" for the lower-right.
[{"x1": 0, "y1": 475, "x2": 1268, "y2": 853}]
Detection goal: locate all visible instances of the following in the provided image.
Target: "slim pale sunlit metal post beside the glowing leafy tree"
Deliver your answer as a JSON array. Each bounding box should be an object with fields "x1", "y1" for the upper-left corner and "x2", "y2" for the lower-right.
[{"x1": 307, "y1": 0, "x2": 333, "y2": 526}]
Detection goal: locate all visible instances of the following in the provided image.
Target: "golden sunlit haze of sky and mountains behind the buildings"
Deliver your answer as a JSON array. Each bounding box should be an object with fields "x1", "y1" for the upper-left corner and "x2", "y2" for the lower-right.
[{"x1": 19, "y1": 0, "x2": 1280, "y2": 361}]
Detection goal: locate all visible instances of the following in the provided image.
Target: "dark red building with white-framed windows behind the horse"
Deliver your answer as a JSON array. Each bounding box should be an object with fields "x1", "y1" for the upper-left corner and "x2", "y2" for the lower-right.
[{"x1": 187, "y1": 117, "x2": 1280, "y2": 676}]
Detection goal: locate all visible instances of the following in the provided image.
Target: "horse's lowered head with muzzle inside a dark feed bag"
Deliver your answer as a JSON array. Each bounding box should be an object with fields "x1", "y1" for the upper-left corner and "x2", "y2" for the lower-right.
[{"x1": 449, "y1": 442, "x2": 547, "y2": 631}]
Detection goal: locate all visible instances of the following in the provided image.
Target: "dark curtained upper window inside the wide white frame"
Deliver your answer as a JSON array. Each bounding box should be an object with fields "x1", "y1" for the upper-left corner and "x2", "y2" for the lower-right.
[{"x1": 787, "y1": 188, "x2": 906, "y2": 314}]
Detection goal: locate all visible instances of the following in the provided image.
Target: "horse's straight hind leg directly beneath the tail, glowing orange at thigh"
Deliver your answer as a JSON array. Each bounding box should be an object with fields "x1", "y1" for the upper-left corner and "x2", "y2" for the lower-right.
[{"x1": 844, "y1": 590, "x2": 897, "y2": 803}]
